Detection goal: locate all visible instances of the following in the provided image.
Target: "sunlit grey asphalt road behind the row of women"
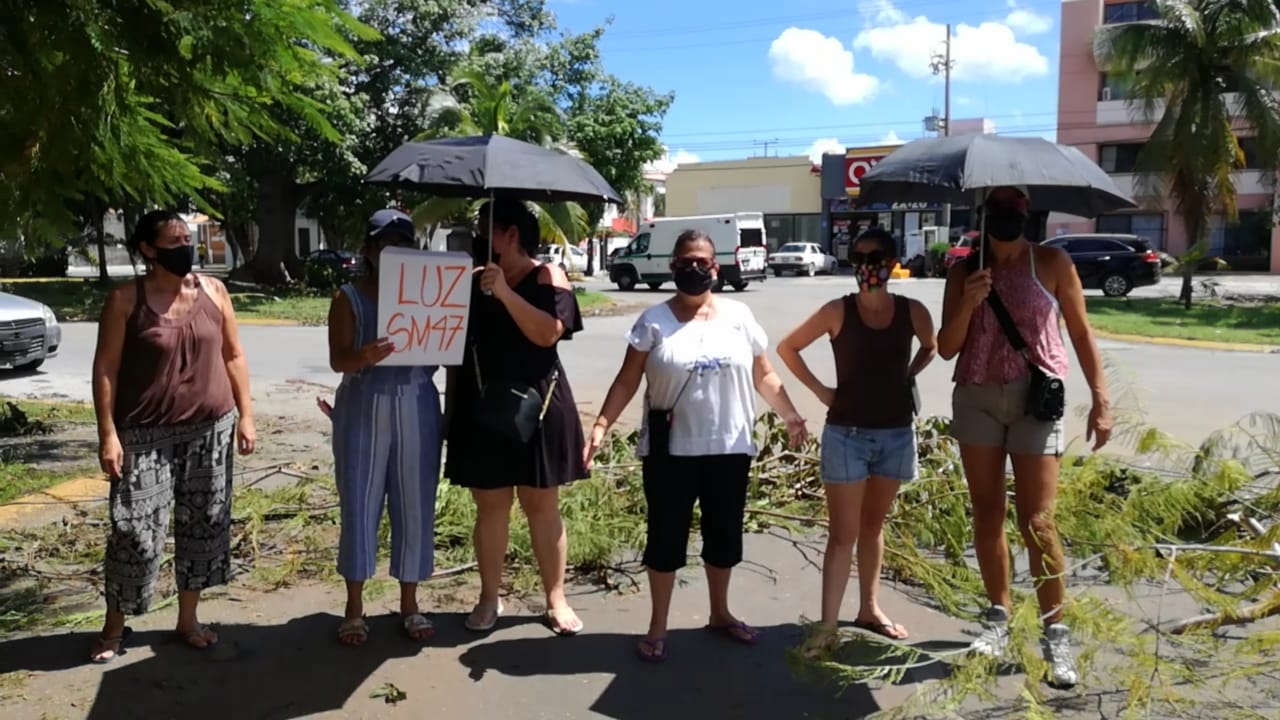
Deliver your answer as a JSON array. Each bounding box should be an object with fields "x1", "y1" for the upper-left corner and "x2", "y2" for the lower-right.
[{"x1": 0, "y1": 275, "x2": 1280, "y2": 442}]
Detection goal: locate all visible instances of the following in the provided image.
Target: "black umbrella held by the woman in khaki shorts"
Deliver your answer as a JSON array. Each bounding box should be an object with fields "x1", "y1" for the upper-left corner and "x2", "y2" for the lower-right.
[{"x1": 858, "y1": 135, "x2": 1137, "y2": 218}]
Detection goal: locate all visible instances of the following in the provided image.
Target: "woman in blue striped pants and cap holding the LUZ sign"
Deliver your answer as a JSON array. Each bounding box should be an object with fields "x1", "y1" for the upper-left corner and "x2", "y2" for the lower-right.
[{"x1": 329, "y1": 210, "x2": 443, "y2": 646}]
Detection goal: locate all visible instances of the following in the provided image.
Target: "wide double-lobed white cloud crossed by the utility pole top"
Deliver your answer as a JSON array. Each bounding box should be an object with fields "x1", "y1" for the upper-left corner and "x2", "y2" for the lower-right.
[{"x1": 852, "y1": 0, "x2": 1048, "y2": 82}]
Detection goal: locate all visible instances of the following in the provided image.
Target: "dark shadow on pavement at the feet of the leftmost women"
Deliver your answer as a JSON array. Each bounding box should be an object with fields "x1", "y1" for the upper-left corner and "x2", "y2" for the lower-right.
[{"x1": 0, "y1": 612, "x2": 514, "y2": 720}]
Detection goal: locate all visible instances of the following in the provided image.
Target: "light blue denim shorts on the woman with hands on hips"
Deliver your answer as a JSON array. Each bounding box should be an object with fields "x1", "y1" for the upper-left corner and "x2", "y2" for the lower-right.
[{"x1": 822, "y1": 425, "x2": 918, "y2": 484}]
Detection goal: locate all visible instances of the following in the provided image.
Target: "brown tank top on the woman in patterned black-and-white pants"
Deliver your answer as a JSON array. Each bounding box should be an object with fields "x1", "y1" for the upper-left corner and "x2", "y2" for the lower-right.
[{"x1": 114, "y1": 278, "x2": 236, "y2": 429}]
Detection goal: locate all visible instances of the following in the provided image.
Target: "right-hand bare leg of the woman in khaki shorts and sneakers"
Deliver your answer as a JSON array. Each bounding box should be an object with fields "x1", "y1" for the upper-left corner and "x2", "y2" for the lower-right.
[{"x1": 1012, "y1": 455, "x2": 1066, "y2": 624}]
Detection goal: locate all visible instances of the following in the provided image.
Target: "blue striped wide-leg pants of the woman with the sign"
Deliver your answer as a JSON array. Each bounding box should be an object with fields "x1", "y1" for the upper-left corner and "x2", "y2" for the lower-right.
[{"x1": 333, "y1": 378, "x2": 444, "y2": 583}]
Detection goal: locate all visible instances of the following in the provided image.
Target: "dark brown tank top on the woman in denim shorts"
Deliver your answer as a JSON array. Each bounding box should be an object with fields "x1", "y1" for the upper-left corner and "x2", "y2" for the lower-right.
[{"x1": 827, "y1": 295, "x2": 915, "y2": 429}]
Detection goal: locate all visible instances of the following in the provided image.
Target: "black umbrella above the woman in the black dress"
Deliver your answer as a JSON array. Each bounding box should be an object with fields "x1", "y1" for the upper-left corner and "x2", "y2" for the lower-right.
[{"x1": 365, "y1": 135, "x2": 622, "y2": 205}]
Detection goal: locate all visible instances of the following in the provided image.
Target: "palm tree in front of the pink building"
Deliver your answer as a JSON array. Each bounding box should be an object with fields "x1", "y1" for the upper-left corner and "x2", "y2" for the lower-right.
[{"x1": 1093, "y1": 0, "x2": 1280, "y2": 307}]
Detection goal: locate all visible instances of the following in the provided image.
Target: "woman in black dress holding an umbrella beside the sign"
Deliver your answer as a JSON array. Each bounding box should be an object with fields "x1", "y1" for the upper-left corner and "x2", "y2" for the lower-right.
[{"x1": 444, "y1": 200, "x2": 588, "y2": 635}]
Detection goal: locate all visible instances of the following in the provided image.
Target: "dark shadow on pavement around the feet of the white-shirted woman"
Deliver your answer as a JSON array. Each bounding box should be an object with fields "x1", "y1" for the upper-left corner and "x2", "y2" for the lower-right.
[{"x1": 460, "y1": 617, "x2": 879, "y2": 720}]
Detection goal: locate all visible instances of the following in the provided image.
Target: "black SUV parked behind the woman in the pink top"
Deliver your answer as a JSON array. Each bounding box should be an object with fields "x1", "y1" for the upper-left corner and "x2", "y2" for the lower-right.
[{"x1": 1043, "y1": 233, "x2": 1160, "y2": 297}]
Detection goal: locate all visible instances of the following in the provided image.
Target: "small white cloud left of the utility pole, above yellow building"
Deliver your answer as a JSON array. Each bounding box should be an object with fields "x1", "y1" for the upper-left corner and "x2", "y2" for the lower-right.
[{"x1": 769, "y1": 27, "x2": 879, "y2": 106}]
